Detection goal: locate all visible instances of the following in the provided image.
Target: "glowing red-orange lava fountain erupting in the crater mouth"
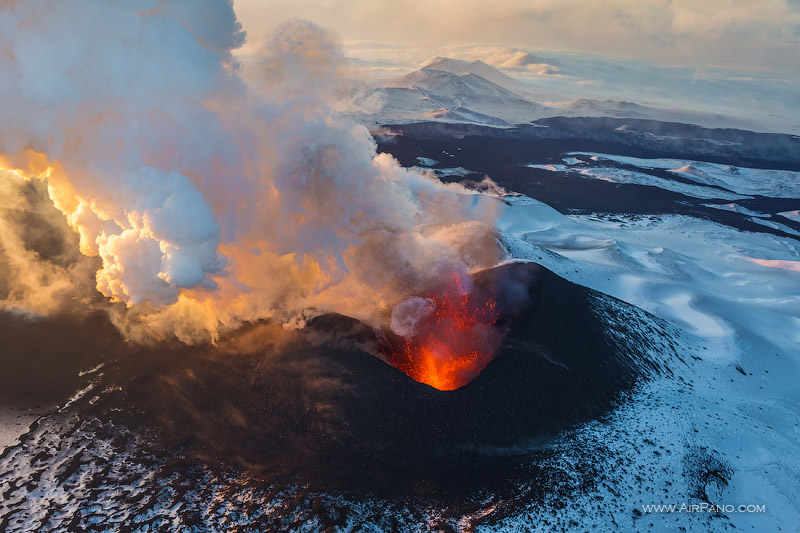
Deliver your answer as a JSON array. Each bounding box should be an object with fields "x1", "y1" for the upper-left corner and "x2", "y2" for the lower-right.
[{"x1": 389, "y1": 273, "x2": 501, "y2": 390}]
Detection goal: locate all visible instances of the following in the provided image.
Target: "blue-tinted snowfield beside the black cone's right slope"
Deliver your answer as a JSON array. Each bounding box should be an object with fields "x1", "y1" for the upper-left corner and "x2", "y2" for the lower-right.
[{"x1": 499, "y1": 193, "x2": 800, "y2": 531}]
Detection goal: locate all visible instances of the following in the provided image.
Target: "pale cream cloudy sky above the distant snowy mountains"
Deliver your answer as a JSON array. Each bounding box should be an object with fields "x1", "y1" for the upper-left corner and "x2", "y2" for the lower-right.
[{"x1": 234, "y1": 0, "x2": 800, "y2": 73}]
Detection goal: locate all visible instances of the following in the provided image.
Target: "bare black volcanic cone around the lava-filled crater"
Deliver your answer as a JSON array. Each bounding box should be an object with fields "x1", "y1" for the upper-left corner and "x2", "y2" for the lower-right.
[{"x1": 31, "y1": 263, "x2": 677, "y2": 486}]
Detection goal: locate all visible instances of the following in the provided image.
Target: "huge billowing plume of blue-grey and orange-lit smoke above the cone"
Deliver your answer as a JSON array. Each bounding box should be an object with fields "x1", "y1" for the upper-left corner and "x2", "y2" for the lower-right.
[{"x1": 0, "y1": 0, "x2": 502, "y2": 341}]
